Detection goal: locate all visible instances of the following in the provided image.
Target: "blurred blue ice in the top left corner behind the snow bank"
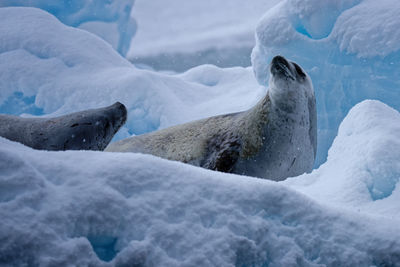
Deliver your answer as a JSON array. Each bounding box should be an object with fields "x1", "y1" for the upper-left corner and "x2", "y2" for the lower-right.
[{"x1": 0, "y1": 0, "x2": 137, "y2": 56}]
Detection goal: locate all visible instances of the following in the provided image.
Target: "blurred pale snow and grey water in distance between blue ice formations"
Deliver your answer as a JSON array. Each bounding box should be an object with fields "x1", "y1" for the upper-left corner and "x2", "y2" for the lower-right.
[{"x1": 127, "y1": 0, "x2": 279, "y2": 71}]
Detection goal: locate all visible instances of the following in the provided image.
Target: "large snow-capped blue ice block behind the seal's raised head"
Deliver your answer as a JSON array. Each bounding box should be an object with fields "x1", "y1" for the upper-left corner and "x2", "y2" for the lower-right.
[{"x1": 252, "y1": 0, "x2": 400, "y2": 168}]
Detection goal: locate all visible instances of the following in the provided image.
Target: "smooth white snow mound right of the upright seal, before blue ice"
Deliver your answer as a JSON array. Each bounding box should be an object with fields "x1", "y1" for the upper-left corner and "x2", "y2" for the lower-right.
[{"x1": 284, "y1": 100, "x2": 400, "y2": 219}]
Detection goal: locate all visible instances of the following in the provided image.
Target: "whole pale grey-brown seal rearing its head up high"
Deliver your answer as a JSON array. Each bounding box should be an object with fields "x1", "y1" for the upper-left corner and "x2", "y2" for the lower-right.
[{"x1": 106, "y1": 56, "x2": 317, "y2": 181}]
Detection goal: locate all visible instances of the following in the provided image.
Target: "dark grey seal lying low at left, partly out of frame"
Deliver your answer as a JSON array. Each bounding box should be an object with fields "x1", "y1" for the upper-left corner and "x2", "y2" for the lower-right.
[{"x1": 0, "y1": 102, "x2": 127, "y2": 150}]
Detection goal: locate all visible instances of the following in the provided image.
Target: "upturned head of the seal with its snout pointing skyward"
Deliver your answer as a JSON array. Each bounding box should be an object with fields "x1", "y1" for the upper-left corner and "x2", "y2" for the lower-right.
[{"x1": 269, "y1": 56, "x2": 314, "y2": 109}]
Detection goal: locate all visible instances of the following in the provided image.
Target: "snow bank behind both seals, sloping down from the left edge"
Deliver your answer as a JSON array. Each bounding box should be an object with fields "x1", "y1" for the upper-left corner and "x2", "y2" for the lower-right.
[{"x1": 0, "y1": 8, "x2": 265, "y2": 138}]
